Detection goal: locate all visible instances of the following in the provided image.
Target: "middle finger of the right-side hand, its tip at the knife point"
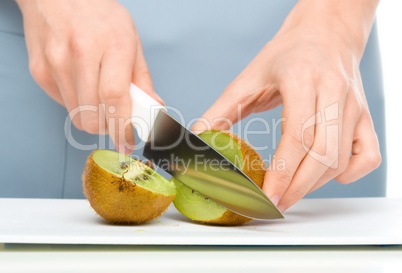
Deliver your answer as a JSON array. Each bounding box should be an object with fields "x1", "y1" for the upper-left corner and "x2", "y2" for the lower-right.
[{"x1": 278, "y1": 73, "x2": 358, "y2": 212}]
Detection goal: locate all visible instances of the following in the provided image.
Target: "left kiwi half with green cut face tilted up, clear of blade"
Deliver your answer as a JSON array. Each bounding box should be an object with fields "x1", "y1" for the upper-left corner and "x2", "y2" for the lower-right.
[{"x1": 82, "y1": 150, "x2": 176, "y2": 224}]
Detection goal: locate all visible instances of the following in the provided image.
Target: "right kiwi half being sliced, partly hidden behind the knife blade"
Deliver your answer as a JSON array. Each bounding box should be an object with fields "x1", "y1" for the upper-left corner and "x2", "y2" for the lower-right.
[{"x1": 171, "y1": 130, "x2": 266, "y2": 226}]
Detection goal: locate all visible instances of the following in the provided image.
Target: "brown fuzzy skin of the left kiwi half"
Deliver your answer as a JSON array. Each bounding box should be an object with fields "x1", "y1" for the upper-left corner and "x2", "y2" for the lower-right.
[{"x1": 82, "y1": 153, "x2": 174, "y2": 224}]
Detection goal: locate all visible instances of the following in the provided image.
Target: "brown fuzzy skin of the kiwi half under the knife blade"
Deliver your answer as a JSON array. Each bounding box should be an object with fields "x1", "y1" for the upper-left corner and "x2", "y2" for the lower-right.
[{"x1": 199, "y1": 131, "x2": 266, "y2": 226}]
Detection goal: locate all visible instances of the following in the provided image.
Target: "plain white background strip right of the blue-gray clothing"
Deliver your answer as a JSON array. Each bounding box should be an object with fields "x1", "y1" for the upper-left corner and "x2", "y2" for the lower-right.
[{"x1": 377, "y1": 0, "x2": 402, "y2": 197}]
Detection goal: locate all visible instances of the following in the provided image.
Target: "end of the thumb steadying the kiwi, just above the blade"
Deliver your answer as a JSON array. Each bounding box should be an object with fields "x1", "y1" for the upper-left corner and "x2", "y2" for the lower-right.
[{"x1": 191, "y1": 86, "x2": 244, "y2": 134}]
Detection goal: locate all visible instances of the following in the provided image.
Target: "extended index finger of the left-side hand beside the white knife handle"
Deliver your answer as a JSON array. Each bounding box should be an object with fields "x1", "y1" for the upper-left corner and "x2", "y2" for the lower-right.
[{"x1": 99, "y1": 49, "x2": 135, "y2": 155}]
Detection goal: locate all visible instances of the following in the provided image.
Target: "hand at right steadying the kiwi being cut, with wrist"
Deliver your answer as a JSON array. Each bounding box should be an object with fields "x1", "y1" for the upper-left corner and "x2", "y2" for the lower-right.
[{"x1": 193, "y1": 0, "x2": 381, "y2": 211}]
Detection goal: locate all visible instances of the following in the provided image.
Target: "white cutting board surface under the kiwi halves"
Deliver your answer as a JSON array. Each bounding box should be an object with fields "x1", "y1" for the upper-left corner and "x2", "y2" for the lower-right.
[{"x1": 0, "y1": 198, "x2": 402, "y2": 245}]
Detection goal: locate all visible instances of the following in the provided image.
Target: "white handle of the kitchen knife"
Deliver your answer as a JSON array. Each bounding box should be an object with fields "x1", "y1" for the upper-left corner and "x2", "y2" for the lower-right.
[{"x1": 130, "y1": 84, "x2": 166, "y2": 141}]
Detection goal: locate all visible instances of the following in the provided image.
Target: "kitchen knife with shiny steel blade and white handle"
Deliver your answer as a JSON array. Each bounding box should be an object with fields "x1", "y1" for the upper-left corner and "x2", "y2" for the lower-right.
[{"x1": 130, "y1": 84, "x2": 284, "y2": 220}]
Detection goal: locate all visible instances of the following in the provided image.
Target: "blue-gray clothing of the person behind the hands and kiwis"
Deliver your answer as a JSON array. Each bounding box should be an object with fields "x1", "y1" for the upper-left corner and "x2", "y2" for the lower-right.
[{"x1": 0, "y1": 0, "x2": 386, "y2": 198}]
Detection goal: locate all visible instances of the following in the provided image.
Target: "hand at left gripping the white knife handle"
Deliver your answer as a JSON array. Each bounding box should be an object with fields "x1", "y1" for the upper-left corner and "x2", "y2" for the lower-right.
[{"x1": 17, "y1": 0, "x2": 163, "y2": 154}]
